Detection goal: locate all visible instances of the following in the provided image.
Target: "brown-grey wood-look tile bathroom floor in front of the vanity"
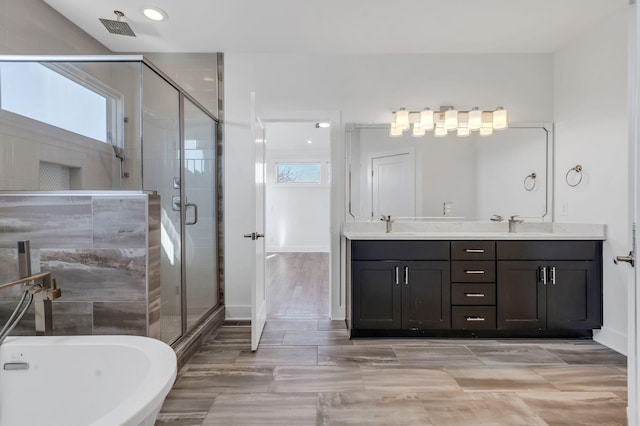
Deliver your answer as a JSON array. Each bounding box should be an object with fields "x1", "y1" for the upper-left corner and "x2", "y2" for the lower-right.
[{"x1": 156, "y1": 255, "x2": 627, "y2": 426}]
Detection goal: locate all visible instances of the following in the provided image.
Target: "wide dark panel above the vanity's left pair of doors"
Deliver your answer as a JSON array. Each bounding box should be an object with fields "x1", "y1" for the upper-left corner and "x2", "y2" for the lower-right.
[{"x1": 351, "y1": 240, "x2": 450, "y2": 261}]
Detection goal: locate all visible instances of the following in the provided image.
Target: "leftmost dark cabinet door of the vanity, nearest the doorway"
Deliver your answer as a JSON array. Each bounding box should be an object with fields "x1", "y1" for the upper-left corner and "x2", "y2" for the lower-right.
[{"x1": 351, "y1": 260, "x2": 402, "y2": 330}]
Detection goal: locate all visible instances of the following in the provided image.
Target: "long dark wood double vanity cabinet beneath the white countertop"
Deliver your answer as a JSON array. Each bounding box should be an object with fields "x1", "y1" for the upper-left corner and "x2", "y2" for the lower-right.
[{"x1": 347, "y1": 240, "x2": 602, "y2": 337}]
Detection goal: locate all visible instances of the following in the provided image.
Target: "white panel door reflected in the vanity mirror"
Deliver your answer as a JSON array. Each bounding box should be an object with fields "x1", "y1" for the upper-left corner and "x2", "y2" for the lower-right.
[{"x1": 371, "y1": 153, "x2": 415, "y2": 218}]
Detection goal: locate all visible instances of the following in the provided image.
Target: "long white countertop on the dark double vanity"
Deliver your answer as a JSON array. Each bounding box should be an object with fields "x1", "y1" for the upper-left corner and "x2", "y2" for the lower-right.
[{"x1": 343, "y1": 222, "x2": 606, "y2": 240}]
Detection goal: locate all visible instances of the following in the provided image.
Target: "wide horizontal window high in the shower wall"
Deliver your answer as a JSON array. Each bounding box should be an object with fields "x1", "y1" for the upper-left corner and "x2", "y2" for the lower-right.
[{"x1": 0, "y1": 62, "x2": 123, "y2": 147}]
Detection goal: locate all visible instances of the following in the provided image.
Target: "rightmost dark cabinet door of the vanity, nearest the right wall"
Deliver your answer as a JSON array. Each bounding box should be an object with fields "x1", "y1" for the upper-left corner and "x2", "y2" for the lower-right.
[{"x1": 547, "y1": 261, "x2": 602, "y2": 330}]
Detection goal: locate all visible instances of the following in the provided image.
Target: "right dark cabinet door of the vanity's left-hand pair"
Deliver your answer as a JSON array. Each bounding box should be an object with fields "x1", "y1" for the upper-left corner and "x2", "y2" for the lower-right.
[{"x1": 402, "y1": 261, "x2": 451, "y2": 330}]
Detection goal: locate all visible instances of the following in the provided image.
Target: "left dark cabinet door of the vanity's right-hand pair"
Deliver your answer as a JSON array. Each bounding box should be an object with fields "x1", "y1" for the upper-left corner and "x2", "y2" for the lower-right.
[{"x1": 496, "y1": 261, "x2": 547, "y2": 330}]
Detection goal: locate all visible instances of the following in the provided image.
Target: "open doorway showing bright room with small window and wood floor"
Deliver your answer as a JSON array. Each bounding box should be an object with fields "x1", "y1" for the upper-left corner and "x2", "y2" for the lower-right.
[{"x1": 265, "y1": 121, "x2": 331, "y2": 320}]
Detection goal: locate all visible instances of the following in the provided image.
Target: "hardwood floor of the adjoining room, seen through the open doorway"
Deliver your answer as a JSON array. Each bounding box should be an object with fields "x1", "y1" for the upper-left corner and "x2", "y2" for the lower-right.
[{"x1": 266, "y1": 253, "x2": 329, "y2": 319}]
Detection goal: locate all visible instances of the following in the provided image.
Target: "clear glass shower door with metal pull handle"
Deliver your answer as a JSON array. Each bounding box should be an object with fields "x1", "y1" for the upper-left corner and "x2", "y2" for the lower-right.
[{"x1": 183, "y1": 98, "x2": 218, "y2": 328}]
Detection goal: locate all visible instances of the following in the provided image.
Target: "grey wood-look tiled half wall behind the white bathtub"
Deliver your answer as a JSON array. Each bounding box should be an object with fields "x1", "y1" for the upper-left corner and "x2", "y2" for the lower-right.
[{"x1": 0, "y1": 191, "x2": 160, "y2": 338}]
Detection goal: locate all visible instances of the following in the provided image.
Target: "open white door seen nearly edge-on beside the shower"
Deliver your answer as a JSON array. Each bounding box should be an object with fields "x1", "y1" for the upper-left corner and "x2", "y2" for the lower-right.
[{"x1": 245, "y1": 92, "x2": 267, "y2": 351}]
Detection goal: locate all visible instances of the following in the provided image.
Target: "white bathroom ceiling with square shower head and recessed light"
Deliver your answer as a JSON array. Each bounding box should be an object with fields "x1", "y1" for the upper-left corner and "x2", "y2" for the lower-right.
[{"x1": 44, "y1": 0, "x2": 628, "y2": 54}]
